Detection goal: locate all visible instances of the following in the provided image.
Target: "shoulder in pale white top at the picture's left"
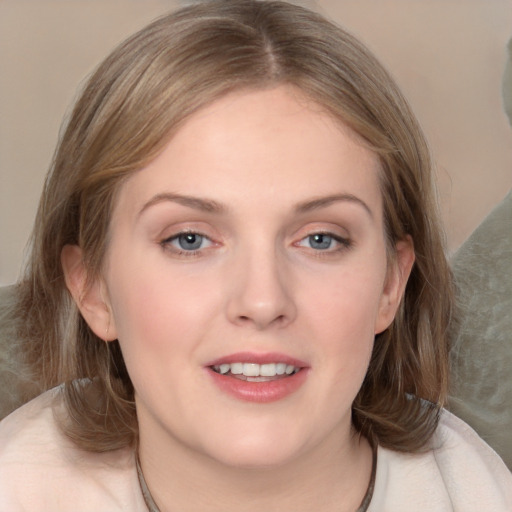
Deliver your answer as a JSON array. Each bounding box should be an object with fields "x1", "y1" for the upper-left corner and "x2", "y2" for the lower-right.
[{"x1": 0, "y1": 388, "x2": 144, "y2": 512}]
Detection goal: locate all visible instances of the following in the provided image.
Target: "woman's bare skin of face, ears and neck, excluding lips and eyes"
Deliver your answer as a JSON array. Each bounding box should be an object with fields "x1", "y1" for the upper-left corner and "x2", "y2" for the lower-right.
[{"x1": 62, "y1": 86, "x2": 414, "y2": 512}]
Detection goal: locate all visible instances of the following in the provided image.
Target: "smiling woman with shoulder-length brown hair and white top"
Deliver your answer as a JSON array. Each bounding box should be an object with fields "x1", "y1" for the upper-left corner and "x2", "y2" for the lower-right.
[{"x1": 0, "y1": 0, "x2": 512, "y2": 512}]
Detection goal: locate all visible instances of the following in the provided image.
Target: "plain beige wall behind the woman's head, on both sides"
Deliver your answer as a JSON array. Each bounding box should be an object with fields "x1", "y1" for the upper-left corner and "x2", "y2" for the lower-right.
[{"x1": 0, "y1": 0, "x2": 512, "y2": 285}]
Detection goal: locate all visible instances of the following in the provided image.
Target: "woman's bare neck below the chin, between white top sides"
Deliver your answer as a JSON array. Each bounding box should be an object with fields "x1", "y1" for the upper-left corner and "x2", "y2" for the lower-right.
[{"x1": 139, "y1": 424, "x2": 372, "y2": 512}]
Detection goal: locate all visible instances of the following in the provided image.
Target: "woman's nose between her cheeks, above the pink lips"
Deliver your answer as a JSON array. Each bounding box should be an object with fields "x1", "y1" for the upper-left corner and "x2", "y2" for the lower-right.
[{"x1": 227, "y1": 248, "x2": 297, "y2": 330}]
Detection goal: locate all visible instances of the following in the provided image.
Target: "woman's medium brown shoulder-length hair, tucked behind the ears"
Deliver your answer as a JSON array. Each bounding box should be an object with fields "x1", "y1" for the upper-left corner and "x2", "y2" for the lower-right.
[{"x1": 13, "y1": 0, "x2": 452, "y2": 451}]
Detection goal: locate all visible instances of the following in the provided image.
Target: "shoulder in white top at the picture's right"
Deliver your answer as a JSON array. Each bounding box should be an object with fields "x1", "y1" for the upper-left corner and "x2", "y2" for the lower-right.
[{"x1": 369, "y1": 411, "x2": 512, "y2": 512}]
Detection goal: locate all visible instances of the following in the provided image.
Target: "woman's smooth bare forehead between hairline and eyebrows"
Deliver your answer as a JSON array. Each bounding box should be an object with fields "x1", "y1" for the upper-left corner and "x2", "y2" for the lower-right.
[{"x1": 113, "y1": 86, "x2": 381, "y2": 222}]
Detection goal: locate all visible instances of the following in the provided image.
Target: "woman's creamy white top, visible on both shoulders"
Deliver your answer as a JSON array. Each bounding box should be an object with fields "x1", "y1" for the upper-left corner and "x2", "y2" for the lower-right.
[{"x1": 0, "y1": 391, "x2": 512, "y2": 512}]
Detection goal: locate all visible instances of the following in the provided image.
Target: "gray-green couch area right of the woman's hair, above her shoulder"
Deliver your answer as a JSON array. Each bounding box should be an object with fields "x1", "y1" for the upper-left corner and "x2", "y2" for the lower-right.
[{"x1": 449, "y1": 192, "x2": 512, "y2": 470}]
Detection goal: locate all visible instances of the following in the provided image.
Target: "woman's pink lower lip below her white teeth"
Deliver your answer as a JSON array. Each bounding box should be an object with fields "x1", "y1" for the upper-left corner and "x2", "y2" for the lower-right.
[{"x1": 207, "y1": 368, "x2": 308, "y2": 403}]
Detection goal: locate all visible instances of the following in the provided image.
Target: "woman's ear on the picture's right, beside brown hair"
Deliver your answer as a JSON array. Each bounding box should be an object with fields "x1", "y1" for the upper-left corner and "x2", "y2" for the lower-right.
[{"x1": 375, "y1": 236, "x2": 415, "y2": 334}]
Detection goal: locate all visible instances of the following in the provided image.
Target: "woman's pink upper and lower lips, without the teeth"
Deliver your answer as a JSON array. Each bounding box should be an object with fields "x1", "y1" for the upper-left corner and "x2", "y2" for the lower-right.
[{"x1": 205, "y1": 352, "x2": 309, "y2": 403}]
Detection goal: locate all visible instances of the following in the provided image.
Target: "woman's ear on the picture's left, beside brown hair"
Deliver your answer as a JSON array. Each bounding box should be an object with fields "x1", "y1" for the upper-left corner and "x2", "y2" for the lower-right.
[{"x1": 61, "y1": 245, "x2": 117, "y2": 341}]
